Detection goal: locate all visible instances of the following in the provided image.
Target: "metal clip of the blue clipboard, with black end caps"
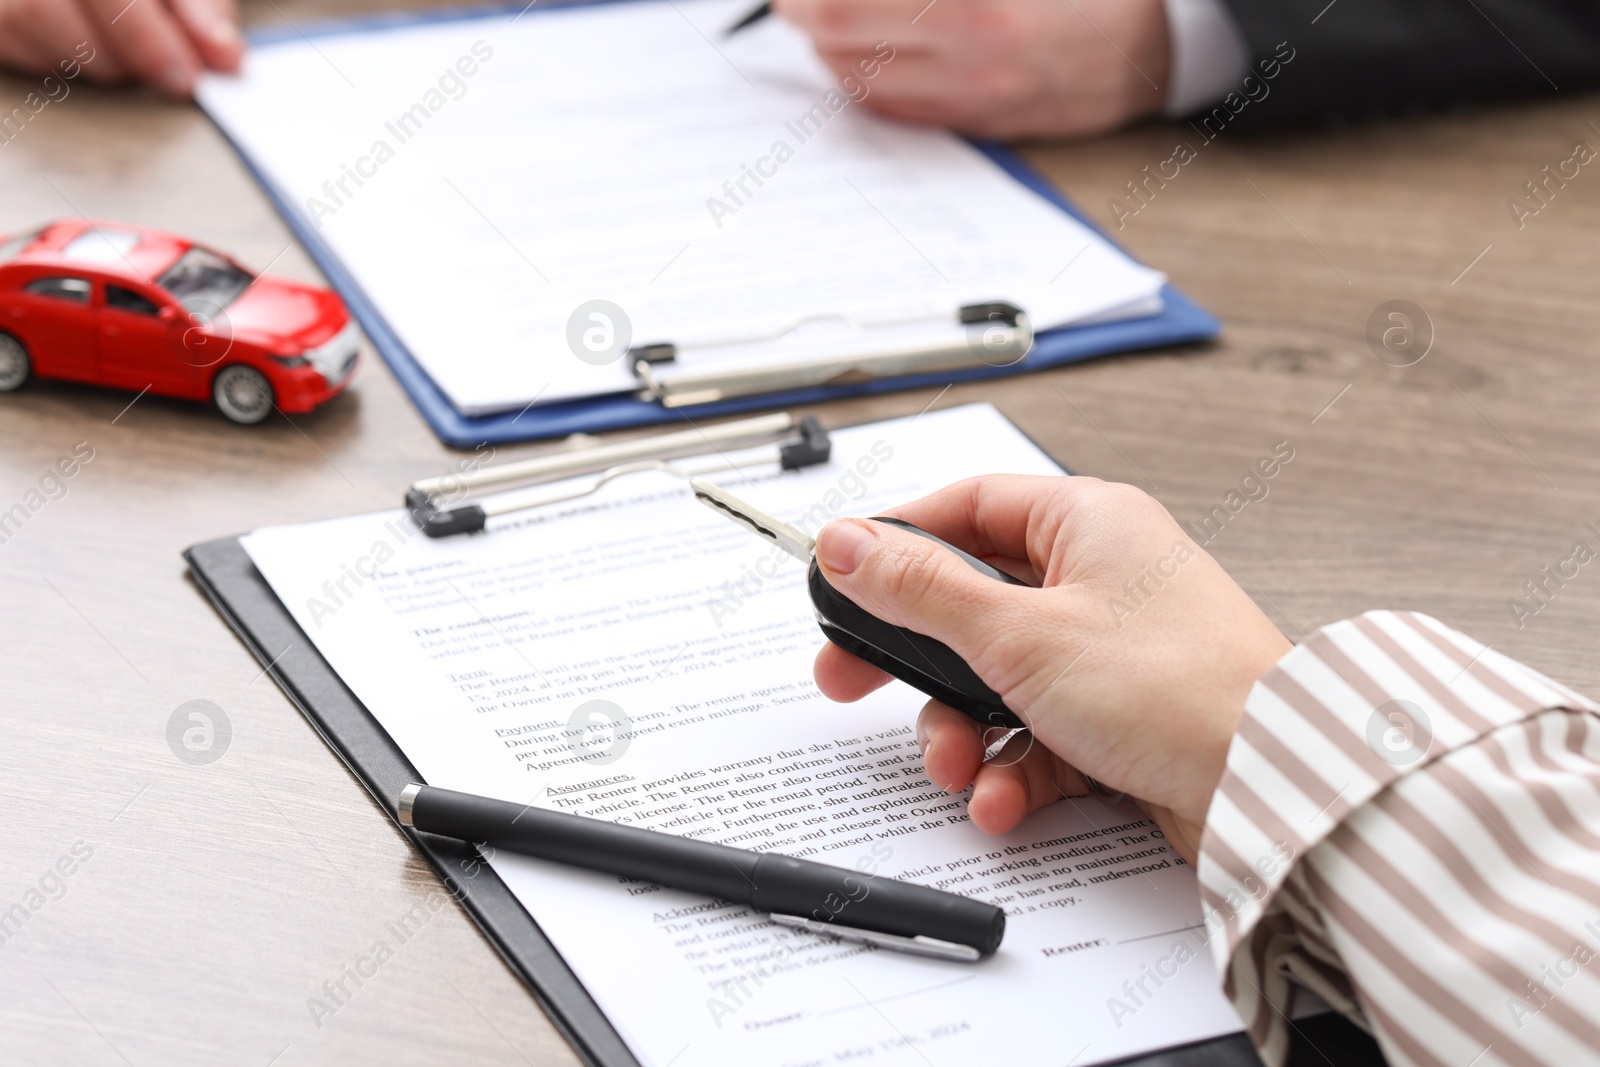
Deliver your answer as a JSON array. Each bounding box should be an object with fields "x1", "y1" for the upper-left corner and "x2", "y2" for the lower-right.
[{"x1": 627, "y1": 301, "x2": 1034, "y2": 408}]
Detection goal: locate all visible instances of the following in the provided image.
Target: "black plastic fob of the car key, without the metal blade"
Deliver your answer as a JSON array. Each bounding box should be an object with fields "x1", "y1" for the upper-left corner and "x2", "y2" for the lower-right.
[{"x1": 806, "y1": 518, "x2": 1026, "y2": 729}]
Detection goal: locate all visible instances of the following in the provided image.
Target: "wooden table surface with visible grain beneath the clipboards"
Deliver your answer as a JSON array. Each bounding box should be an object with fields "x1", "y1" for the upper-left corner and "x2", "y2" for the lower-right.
[{"x1": 0, "y1": 0, "x2": 1600, "y2": 1067}]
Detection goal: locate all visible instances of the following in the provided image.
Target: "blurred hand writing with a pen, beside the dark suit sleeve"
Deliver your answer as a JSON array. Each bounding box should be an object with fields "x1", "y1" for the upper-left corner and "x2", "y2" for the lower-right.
[{"x1": 773, "y1": 0, "x2": 1171, "y2": 138}]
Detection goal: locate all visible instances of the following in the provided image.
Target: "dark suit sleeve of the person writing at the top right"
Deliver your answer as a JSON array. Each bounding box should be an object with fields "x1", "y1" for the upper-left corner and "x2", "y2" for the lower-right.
[{"x1": 1226, "y1": 0, "x2": 1600, "y2": 126}]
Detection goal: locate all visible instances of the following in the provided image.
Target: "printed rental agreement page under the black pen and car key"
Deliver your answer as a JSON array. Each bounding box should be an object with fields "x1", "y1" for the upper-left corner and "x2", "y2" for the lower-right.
[{"x1": 245, "y1": 406, "x2": 1238, "y2": 1067}]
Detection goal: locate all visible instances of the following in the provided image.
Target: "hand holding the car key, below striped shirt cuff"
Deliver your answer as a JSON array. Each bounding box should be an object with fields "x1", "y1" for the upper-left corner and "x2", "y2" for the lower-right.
[{"x1": 816, "y1": 475, "x2": 1290, "y2": 861}]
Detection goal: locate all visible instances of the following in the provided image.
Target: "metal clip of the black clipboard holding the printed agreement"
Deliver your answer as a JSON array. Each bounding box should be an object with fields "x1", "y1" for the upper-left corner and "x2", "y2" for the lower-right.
[{"x1": 405, "y1": 414, "x2": 832, "y2": 537}]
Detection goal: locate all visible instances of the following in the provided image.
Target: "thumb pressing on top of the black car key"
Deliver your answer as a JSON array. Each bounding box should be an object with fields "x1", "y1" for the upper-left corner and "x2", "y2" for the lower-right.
[{"x1": 816, "y1": 518, "x2": 1037, "y2": 675}]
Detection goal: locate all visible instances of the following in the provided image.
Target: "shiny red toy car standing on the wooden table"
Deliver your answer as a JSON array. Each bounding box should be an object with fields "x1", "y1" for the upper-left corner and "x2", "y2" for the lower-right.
[{"x1": 0, "y1": 221, "x2": 360, "y2": 422}]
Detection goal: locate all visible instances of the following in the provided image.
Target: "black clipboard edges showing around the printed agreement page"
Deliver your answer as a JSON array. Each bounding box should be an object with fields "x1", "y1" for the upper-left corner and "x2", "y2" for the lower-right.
[{"x1": 184, "y1": 537, "x2": 1384, "y2": 1067}]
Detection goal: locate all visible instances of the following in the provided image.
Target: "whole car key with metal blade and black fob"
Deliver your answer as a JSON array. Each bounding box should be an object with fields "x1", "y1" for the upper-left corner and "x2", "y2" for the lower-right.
[{"x1": 690, "y1": 478, "x2": 1026, "y2": 729}]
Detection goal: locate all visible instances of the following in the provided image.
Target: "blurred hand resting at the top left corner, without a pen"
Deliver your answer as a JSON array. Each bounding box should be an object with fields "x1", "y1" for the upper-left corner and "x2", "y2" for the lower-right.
[{"x1": 0, "y1": 0, "x2": 245, "y2": 98}]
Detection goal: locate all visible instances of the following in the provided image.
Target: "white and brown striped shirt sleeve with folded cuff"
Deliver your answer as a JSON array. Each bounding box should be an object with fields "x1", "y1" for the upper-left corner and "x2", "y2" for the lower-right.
[{"x1": 1198, "y1": 611, "x2": 1600, "y2": 1067}]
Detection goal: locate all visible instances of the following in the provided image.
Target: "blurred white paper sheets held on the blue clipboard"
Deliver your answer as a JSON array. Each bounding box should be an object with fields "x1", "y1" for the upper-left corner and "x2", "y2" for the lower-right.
[{"x1": 198, "y1": 0, "x2": 1163, "y2": 414}]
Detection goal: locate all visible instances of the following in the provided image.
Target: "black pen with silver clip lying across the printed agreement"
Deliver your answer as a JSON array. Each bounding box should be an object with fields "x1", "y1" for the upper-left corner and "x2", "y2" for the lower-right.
[{"x1": 397, "y1": 785, "x2": 1005, "y2": 961}]
